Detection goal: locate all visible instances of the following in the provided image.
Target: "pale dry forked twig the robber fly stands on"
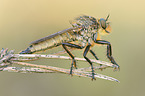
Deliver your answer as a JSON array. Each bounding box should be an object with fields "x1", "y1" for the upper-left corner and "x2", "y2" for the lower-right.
[{"x1": 0, "y1": 49, "x2": 119, "y2": 82}]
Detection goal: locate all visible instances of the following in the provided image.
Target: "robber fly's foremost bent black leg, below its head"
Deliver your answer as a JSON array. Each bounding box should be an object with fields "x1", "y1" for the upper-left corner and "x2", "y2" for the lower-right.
[{"x1": 95, "y1": 40, "x2": 120, "y2": 69}]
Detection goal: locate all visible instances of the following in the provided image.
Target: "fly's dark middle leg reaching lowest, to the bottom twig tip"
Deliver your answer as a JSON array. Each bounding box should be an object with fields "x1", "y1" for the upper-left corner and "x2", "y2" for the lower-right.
[{"x1": 83, "y1": 45, "x2": 96, "y2": 80}]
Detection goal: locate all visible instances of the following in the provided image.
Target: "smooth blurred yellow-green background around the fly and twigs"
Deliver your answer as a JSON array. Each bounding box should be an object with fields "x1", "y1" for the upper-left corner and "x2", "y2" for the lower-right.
[{"x1": 0, "y1": 0, "x2": 145, "y2": 96}]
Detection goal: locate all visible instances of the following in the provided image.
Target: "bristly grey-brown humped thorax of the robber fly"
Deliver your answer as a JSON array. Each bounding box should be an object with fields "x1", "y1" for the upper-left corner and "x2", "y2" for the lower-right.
[{"x1": 71, "y1": 15, "x2": 98, "y2": 47}]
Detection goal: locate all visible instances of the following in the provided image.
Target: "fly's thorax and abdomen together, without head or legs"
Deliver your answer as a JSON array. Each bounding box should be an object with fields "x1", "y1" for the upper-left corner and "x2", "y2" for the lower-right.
[{"x1": 21, "y1": 16, "x2": 103, "y2": 54}]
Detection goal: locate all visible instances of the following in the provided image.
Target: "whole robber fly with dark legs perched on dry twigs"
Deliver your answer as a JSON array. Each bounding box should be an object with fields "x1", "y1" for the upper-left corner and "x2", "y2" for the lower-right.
[{"x1": 20, "y1": 15, "x2": 119, "y2": 80}]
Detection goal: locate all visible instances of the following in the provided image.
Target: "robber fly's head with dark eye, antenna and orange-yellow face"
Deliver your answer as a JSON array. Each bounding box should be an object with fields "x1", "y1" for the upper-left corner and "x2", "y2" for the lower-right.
[{"x1": 98, "y1": 15, "x2": 111, "y2": 33}]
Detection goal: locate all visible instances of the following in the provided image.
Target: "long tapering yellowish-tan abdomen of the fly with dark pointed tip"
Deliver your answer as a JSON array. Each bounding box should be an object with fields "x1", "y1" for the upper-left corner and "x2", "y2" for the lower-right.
[{"x1": 20, "y1": 28, "x2": 77, "y2": 54}]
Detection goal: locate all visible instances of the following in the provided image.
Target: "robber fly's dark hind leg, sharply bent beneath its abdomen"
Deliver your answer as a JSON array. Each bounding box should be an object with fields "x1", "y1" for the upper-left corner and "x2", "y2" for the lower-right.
[{"x1": 62, "y1": 43, "x2": 83, "y2": 75}]
